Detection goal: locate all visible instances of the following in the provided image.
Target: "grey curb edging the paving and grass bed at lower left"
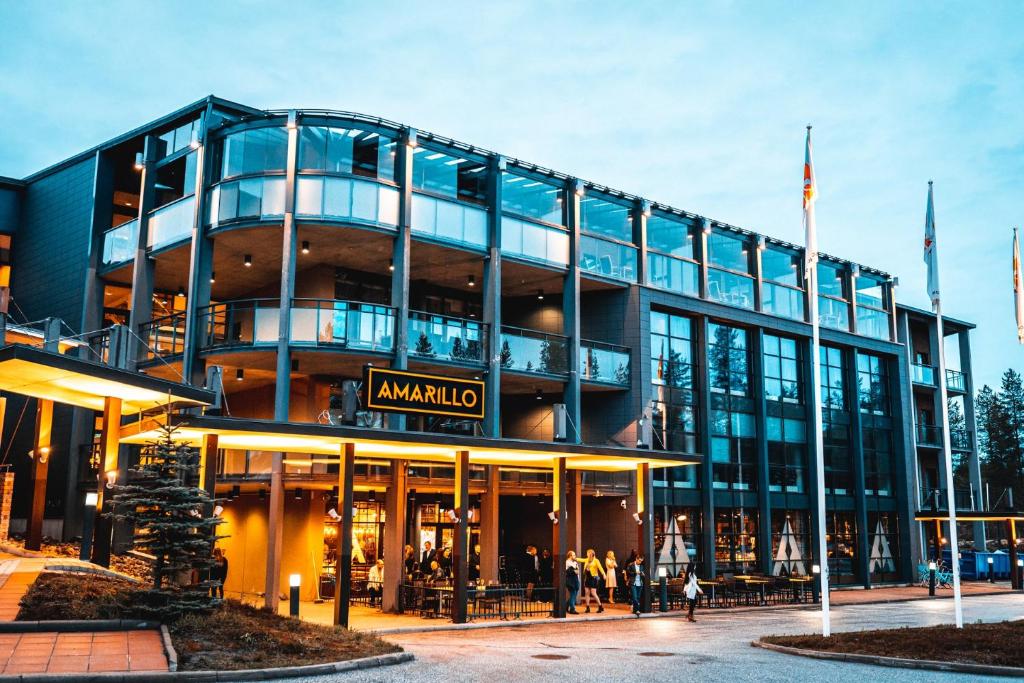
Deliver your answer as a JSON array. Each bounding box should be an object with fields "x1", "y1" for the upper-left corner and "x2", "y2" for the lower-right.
[{"x1": 0, "y1": 652, "x2": 416, "y2": 683}]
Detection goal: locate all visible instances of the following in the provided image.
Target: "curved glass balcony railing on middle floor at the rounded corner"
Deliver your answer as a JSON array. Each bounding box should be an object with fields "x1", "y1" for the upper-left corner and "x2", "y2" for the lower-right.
[{"x1": 198, "y1": 299, "x2": 394, "y2": 352}]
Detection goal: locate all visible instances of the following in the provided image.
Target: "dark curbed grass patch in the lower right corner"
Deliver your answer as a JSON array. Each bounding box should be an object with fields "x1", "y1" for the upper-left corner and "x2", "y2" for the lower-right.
[{"x1": 761, "y1": 622, "x2": 1024, "y2": 667}]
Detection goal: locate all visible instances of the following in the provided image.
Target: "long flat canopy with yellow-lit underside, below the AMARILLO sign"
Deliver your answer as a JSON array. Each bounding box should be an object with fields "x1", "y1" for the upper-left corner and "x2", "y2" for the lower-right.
[{"x1": 121, "y1": 415, "x2": 701, "y2": 472}]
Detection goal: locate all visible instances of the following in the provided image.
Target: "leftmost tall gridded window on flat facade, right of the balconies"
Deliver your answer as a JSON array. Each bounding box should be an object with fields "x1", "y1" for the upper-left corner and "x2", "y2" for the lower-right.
[{"x1": 650, "y1": 310, "x2": 696, "y2": 462}]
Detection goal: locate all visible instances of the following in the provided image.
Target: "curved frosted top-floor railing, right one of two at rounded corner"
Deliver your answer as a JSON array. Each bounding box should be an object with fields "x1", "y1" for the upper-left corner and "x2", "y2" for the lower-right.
[{"x1": 295, "y1": 176, "x2": 398, "y2": 226}]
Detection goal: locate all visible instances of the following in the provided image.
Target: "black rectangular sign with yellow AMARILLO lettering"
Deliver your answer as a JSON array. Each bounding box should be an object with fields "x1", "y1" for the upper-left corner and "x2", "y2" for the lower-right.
[{"x1": 366, "y1": 368, "x2": 483, "y2": 420}]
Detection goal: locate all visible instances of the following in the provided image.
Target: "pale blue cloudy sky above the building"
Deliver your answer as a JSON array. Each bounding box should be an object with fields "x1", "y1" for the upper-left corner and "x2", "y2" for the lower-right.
[{"x1": 0, "y1": 0, "x2": 1024, "y2": 387}]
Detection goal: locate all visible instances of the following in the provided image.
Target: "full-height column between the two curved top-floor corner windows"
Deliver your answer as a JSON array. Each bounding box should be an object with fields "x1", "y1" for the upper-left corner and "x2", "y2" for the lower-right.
[{"x1": 263, "y1": 110, "x2": 299, "y2": 612}]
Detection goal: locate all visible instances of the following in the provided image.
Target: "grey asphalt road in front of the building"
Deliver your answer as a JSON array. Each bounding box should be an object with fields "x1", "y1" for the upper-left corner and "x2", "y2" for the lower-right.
[{"x1": 311, "y1": 594, "x2": 1024, "y2": 683}]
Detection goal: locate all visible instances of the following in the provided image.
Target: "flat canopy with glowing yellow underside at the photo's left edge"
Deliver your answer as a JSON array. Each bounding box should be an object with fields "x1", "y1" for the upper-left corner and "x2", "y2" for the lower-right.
[{"x1": 0, "y1": 344, "x2": 215, "y2": 415}]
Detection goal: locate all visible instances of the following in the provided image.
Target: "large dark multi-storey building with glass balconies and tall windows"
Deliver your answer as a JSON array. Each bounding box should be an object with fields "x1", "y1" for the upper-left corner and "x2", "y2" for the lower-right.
[{"x1": 0, "y1": 97, "x2": 984, "y2": 614}]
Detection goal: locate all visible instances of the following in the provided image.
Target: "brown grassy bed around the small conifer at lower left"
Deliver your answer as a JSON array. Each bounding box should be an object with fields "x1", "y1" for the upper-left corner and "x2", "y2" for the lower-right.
[{"x1": 17, "y1": 572, "x2": 401, "y2": 671}]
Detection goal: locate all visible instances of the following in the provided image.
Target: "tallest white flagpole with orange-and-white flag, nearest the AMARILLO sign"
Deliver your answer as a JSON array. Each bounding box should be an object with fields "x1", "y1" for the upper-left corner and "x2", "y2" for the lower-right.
[{"x1": 804, "y1": 126, "x2": 831, "y2": 638}]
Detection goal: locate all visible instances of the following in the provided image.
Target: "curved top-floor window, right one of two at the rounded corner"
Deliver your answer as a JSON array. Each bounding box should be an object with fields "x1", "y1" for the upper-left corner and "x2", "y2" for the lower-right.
[{"x1": 299, "y1": 126, "x2": 395, "y2": 180}]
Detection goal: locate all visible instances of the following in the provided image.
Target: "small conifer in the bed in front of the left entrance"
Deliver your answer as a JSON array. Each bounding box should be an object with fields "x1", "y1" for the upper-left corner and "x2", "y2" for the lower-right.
[{"x1": 112, "y1": 426, "x2": 220, "y2": 622}]
